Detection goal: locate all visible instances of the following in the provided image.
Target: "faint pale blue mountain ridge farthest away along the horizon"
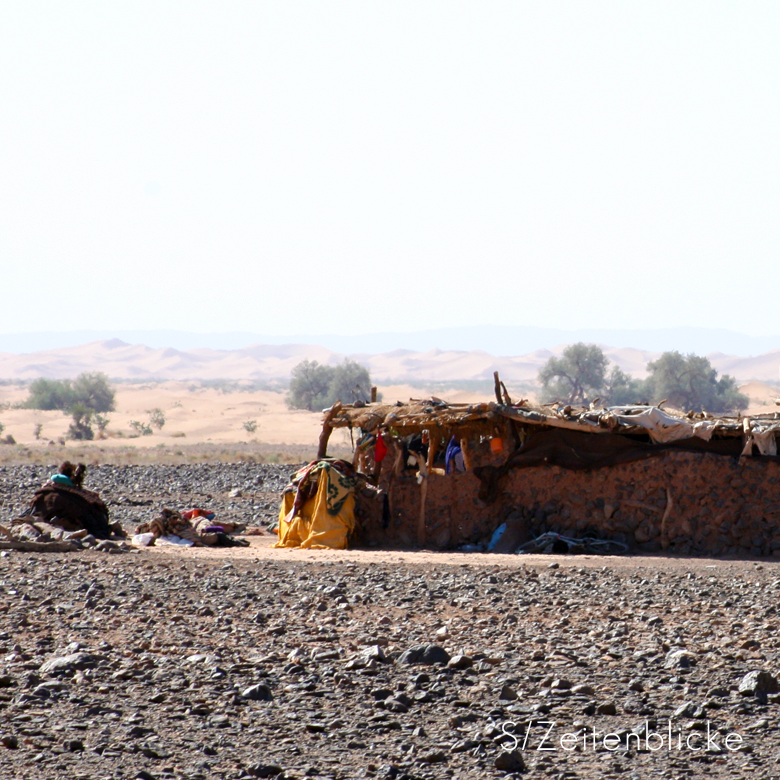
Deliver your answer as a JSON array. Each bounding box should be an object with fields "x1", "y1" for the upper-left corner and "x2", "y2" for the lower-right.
[{"x1": 0, "y1": 325, "x2": 780, "y2": 357}]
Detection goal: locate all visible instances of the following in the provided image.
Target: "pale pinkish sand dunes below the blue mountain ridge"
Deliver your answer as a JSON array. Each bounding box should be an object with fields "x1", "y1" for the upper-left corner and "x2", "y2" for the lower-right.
[{"x1": 0, "y1": 338, "x2": 780, "y2": 382}]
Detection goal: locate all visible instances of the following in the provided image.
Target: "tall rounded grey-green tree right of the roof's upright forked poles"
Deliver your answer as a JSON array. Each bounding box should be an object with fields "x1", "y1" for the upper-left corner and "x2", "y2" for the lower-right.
[{"x1": 539, "y1": 343, "x2": 612, "y2": 404}]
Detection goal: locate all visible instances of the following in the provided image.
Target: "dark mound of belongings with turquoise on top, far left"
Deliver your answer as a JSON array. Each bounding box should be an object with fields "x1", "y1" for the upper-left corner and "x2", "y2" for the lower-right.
[{"x1": 10, "y1": 461, "x2": 126, "y2": 542}]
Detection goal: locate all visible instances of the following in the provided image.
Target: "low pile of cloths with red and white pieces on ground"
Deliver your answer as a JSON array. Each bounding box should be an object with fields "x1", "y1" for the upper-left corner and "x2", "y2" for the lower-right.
[{"x1": 133, "y1": 509, "x2": 249, "y2": 547}]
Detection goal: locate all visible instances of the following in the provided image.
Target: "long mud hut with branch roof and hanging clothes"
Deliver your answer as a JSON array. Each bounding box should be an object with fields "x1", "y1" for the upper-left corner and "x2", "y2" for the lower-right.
[{"x1": 319, "y1": 381, "x2": 780, "y2": 557}]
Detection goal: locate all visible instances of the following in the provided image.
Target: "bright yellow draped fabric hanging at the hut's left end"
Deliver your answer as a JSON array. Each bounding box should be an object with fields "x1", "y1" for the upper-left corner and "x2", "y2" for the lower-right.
[{"x1": 274, "y1": 467, "x2": 355, "y2": 550}]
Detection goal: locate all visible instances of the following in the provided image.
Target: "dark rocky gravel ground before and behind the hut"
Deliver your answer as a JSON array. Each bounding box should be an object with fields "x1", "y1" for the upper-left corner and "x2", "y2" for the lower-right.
[{"x1": 0, "y1": 466, "x2": 780, "y2": 780}]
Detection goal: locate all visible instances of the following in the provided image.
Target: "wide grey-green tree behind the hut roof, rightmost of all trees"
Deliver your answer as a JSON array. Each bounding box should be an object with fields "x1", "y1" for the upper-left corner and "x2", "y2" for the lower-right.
[{"x1": 646, "y1": 351, "x2": 749, "y2": 414}]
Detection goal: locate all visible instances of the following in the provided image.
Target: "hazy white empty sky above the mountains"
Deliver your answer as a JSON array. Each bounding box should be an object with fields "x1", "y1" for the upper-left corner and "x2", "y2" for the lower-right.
[{"x1": 0, "y1": 0, "x2": 780, "y2": 334}]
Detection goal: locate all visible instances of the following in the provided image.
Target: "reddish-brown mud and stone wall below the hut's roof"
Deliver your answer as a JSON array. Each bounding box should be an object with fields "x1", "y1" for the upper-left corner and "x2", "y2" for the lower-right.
[{"x1": 361, "y1": 452, "x2": 780, "y2": 558}]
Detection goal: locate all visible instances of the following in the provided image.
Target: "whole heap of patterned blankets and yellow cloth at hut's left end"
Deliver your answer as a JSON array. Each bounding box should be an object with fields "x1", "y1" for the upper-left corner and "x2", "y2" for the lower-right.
[{"x1": 274, "y1": 458, "x2": 360, "y2": 550}]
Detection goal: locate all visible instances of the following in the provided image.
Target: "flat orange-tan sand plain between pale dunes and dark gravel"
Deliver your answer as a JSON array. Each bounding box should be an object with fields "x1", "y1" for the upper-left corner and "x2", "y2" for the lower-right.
[{"x1": 0, "y1": 380, "x2": 780, "y2": 461}]
